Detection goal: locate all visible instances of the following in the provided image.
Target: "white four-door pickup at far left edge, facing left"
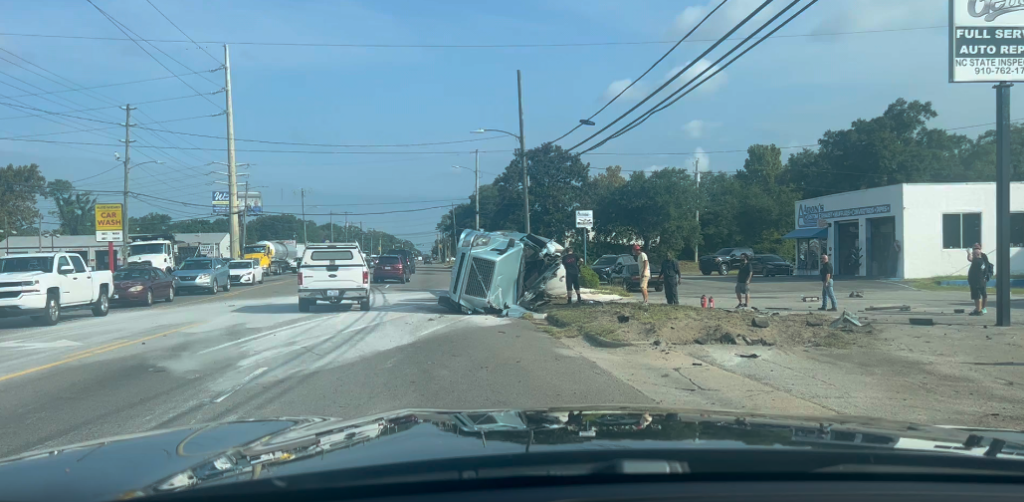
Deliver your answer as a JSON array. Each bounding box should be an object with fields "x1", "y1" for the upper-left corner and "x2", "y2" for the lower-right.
[{"x1": 0, "y1": 253, "x2": 114, "y2": 326}]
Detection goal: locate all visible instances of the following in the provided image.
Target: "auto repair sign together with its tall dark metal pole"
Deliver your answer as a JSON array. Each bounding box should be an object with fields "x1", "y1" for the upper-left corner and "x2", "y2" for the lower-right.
[{"x1": 949, "y1": 0, "x2": 1024, "y2": 326}]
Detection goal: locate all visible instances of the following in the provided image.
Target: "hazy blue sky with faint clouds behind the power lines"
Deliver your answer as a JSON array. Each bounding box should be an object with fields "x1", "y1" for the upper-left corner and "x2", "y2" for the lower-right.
[{"x1": 0, "y1": 0, "x2": 1007, "y2": 247}]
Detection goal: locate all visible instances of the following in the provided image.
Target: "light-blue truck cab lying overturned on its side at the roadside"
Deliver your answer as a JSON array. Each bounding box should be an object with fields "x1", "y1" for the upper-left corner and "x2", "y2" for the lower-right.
[{"x1": 437, "y1": 229, "x2": 564, "y2": 316}]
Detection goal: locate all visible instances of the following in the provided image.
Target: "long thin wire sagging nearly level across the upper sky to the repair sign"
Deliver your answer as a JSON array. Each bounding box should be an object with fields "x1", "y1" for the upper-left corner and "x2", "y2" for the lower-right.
[{"x1": 0, "y1": 25, "x2": 949, "y2": 49}]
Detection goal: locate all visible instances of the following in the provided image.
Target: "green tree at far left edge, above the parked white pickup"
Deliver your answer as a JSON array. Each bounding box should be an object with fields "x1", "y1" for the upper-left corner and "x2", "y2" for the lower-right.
[{"x1": 0, "y1": 164, "x2": 46, "y2": 238}]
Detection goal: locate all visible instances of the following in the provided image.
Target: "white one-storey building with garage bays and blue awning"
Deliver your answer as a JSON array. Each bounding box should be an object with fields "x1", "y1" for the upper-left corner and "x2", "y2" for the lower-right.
[{"x1": 784, "y1": 182, "x2": 1024, "y2": 279}]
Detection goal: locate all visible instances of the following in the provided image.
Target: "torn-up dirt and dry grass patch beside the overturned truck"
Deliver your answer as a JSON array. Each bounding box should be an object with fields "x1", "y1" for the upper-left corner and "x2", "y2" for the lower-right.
[{"x1": 545, "y1": 303, "x2": 870, "y2": 348}]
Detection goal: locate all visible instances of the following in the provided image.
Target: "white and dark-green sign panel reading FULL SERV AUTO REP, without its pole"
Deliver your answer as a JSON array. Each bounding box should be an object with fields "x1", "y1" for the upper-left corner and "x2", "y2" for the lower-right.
[{"x1": 949, "y1": 0, "x2": 1024, "y2": 82}]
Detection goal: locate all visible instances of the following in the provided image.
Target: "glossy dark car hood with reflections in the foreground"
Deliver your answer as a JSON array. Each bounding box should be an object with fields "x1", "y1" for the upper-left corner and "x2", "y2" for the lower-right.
[{"x1": 0, "y1": 407, "x2": 1024, "y2": 501}]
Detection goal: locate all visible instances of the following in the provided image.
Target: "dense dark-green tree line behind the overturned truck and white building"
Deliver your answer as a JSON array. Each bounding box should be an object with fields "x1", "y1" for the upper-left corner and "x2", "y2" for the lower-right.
[{"x1": 433, "y1": 98, "x2": 1024, "y2": 260}]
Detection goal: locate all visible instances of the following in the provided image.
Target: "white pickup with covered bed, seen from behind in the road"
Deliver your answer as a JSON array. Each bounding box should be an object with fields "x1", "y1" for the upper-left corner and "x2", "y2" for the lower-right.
[{"x1": 299, "y1": 243, "x2": 370, "y2": 312}]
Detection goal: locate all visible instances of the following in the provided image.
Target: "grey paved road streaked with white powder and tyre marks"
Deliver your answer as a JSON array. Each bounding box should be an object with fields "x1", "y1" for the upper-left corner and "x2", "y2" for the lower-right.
[{"x1": 0, "y1": 266, "x2": 651, "y2": 457}]
